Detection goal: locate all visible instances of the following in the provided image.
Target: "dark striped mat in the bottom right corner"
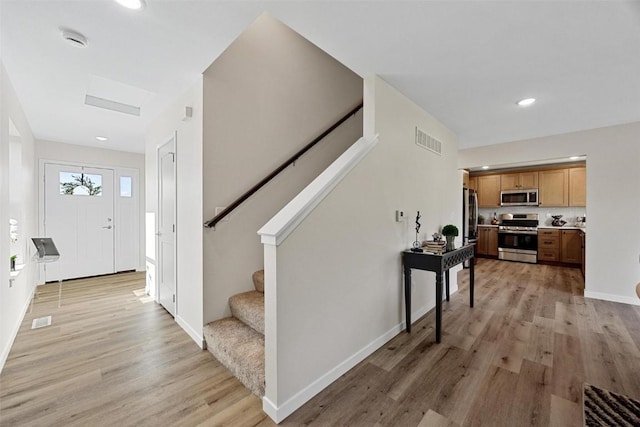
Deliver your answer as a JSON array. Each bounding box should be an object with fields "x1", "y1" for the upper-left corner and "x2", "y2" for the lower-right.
[{"x1": 583, "y1": 383, "x2": 640, "y2": 427}]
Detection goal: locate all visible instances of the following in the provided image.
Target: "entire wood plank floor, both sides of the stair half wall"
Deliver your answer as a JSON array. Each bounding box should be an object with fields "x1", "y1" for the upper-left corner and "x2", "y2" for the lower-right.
[{"x1": 0, "y1": 260, "x2": 640, "y2": 427}]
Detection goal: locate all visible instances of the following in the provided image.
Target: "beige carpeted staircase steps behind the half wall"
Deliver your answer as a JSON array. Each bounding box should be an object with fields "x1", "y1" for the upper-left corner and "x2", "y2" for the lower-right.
[{"x1": 204, "y1": 270, "x2": 264, "y2": 397}]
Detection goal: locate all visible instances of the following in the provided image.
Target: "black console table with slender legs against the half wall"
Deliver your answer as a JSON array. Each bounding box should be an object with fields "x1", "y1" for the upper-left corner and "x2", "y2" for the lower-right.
[{"x1": 402, "y1": 243, "x2": 475, "y2": 342}]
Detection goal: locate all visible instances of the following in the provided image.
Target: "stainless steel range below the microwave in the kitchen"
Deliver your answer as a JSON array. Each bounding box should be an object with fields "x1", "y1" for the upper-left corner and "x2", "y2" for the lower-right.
[{"x1": 498, "y1": 214, "x2": 538, "y2": 264}]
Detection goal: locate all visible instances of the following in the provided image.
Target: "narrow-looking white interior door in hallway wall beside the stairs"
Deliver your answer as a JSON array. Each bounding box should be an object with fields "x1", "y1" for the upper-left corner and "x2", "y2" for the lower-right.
[{"x1": 156, "y1": 135, "x2": 176, "y2": 317}]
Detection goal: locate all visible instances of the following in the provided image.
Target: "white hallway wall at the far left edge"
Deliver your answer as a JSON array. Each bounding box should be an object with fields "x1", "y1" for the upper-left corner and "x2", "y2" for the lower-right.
[{"x1": 0, "y1": 62, "x2": 37, "y2": 371}]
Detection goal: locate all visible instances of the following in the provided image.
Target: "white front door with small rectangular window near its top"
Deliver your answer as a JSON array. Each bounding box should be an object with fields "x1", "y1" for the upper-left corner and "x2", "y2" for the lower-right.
[{"x1": 43, "y1": 163, "x2": 116, "y2": 281}]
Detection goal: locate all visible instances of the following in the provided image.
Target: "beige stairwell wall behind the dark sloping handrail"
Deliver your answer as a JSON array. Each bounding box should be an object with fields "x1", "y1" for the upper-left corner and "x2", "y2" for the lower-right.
[{"x1": 203, "y1": 14, "x2": 362, "y2": 323}]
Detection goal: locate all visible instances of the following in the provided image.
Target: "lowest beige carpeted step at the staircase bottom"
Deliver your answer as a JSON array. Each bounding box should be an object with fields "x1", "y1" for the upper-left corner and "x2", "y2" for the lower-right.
[{"x1": 204, "y1": 317, "x2": 264, "y2": 397}]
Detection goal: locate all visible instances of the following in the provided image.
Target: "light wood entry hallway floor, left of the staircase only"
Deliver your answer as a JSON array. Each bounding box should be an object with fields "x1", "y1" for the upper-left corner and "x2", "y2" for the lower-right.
[{"x1": 0, "y1": 273, "x2": 270, "y2": 427}]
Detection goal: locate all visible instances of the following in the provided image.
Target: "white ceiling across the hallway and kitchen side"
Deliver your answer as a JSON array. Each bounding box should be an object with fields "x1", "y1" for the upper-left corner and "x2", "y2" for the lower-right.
[{"x1": 0, "y1": 0, "x2": 640, "y2": 152}]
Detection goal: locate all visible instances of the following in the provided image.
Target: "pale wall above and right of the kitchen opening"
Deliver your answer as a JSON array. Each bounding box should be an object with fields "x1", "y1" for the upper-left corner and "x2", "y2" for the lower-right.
[{"x1": 459, "y1": 123, "x2": 640, "y2": 304}]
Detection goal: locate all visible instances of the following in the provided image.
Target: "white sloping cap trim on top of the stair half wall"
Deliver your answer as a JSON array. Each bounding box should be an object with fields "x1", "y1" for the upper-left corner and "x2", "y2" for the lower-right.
[{"x1": 258, "y1": 135, "x2": 378, "y2": 246}]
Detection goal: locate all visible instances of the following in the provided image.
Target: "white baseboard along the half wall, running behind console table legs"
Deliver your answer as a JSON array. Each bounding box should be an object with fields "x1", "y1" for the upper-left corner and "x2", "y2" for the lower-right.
[{"x1": 262, "y1": 284, "x2": 458, "y2": 423}]
